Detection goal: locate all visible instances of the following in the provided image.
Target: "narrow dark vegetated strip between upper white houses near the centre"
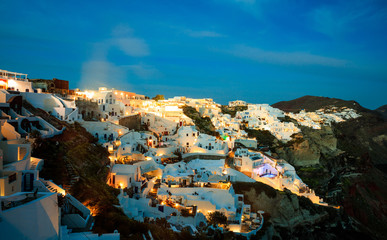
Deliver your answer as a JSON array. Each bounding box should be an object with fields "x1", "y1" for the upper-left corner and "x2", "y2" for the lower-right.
[{"x1": 183, "y1": 105, "x2": 219, "y2": 136}]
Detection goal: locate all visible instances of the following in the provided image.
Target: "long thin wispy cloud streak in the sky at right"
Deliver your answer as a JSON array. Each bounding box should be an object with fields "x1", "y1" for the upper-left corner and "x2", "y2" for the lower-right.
[{"x1": 227, "y1": 45, "x2": 347, "y2": 67}]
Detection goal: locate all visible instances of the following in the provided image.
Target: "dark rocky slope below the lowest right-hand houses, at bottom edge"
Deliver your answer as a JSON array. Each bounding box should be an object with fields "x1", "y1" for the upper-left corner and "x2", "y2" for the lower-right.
[{"x1": 233, "y1": 182, "x2": 358, "y2": 239}]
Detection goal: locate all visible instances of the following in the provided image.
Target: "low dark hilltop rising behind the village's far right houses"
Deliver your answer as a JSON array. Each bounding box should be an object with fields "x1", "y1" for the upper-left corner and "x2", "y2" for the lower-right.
[{"x1": 272, "y1": 96, "x2": 370, "y2": 112}]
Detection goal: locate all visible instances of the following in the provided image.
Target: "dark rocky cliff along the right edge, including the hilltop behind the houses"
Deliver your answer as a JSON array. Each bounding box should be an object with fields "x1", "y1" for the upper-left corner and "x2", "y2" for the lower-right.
[{"x1": 271, "y1": 96, "x2": 387, "y2": 239}]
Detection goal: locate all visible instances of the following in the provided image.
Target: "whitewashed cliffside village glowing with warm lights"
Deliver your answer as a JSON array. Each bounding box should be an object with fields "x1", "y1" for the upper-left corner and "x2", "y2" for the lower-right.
[{"x1": 0, "y1": 70, "x2": 359, "y2": 239}]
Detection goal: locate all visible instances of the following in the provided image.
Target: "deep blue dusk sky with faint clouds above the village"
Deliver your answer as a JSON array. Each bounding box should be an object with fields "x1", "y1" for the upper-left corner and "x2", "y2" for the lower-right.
[{"x1": 0, "y1": 0, "x2": 387, "y2": 109}]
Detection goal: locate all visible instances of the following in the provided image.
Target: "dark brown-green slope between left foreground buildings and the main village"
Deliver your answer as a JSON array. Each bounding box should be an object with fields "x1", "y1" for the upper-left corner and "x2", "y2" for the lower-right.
[{"x1": 32, "y1": 123, "x2": 177, "y2": 239}]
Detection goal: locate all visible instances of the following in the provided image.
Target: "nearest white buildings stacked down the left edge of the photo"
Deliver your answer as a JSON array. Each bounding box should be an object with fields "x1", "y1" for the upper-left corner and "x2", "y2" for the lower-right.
[{"x1": 0, "y1": 76, "x2": 120, "y2": 240}]
